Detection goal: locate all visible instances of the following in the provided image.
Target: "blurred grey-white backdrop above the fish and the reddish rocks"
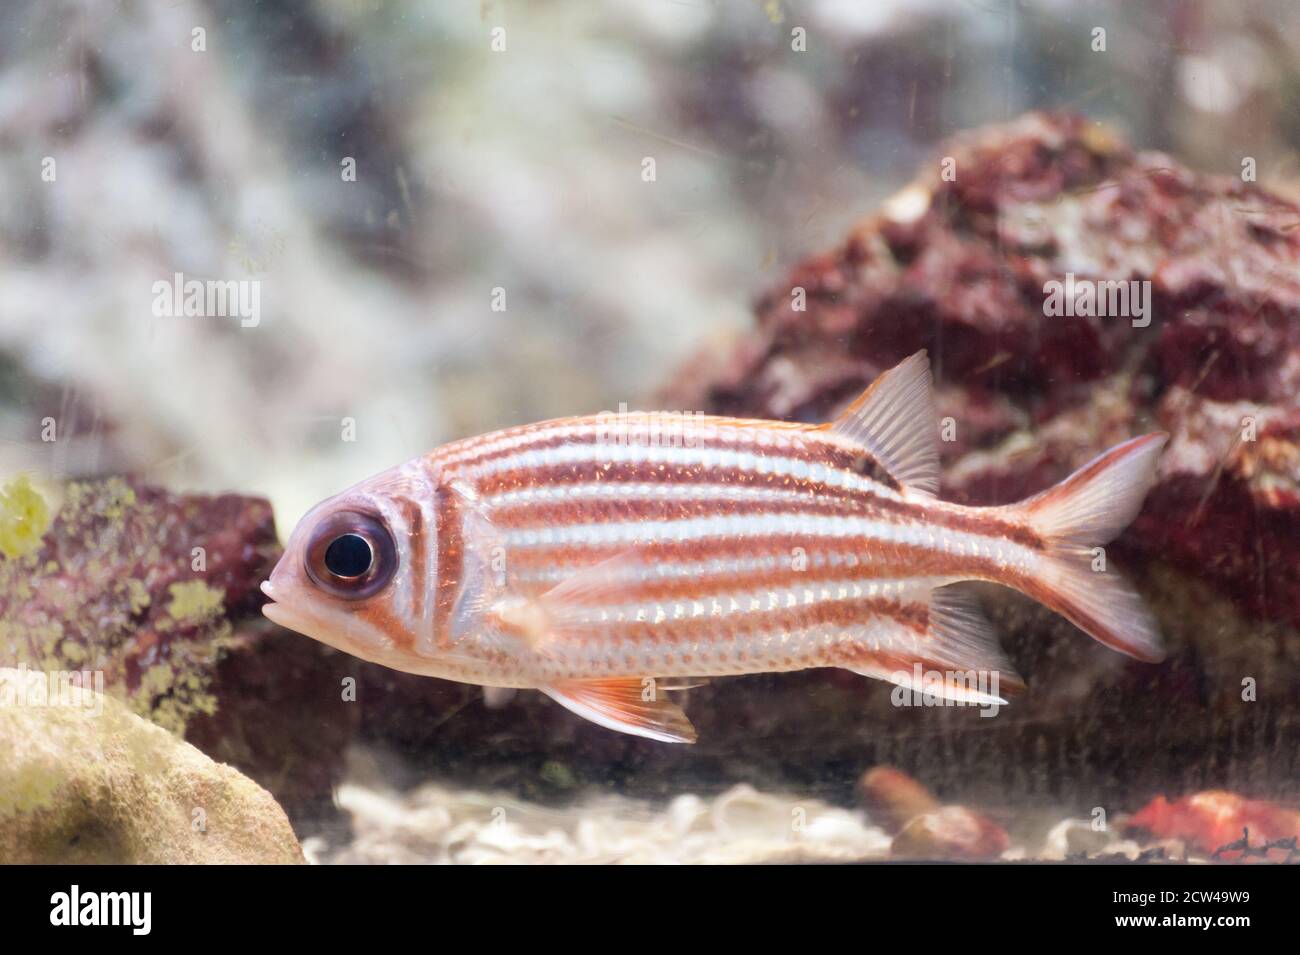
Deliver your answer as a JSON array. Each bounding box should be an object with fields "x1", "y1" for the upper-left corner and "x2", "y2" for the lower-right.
[{"x1": 0, "y1": 0, "x2": 1300, "y2": 535}]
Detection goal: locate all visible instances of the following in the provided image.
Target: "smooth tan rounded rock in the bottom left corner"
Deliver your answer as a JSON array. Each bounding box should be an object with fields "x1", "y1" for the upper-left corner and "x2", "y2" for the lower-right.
[{"x1": 0, "y1": 669, "x2": 303, "y2": 864}]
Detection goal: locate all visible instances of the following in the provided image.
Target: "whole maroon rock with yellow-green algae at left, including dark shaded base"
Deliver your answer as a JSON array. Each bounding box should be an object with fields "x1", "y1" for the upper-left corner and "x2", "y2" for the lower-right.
[{"x1": 0, "y1": 478, "x2": 356, "y2": 817}]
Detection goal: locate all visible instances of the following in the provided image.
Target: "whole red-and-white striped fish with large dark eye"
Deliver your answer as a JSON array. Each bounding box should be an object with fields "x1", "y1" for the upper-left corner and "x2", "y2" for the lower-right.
[{"x1": 263, "y1": 351, "x2": 1169, "y2": 743}]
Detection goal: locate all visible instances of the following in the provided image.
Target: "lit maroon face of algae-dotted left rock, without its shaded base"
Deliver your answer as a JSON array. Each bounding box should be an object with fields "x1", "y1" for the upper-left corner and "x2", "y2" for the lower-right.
[{"x1": 0, "y1": 478, "x2": 278, "y2": 732}]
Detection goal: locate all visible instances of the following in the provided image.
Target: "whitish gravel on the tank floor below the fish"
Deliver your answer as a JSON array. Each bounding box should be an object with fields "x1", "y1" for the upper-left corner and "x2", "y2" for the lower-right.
[{"x1": 303, "y1": 750, "x2": 1159, "y2": 864}]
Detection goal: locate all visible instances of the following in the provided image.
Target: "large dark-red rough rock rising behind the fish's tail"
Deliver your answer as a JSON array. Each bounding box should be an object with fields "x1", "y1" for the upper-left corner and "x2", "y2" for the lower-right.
[{"x1": 664, "y1": 114, "x2": 1300, "y2": 634}]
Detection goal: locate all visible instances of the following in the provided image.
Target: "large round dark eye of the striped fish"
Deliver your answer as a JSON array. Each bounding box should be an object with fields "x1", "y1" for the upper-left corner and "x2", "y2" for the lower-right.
[{"x1": 306, "y1": 511, "x2": 397, "y2": 600}]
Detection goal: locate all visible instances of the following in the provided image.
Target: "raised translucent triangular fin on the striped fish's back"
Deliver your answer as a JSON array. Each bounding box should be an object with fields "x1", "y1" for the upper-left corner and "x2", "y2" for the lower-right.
[{"x1": 831, "y1": 351, "x2": 939, "y2": 495}]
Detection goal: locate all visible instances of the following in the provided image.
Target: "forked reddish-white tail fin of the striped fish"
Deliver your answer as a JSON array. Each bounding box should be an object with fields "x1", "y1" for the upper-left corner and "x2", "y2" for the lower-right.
[{"x1": 1017, "y1": 433, "x2": 1169, "y2": 663}]
